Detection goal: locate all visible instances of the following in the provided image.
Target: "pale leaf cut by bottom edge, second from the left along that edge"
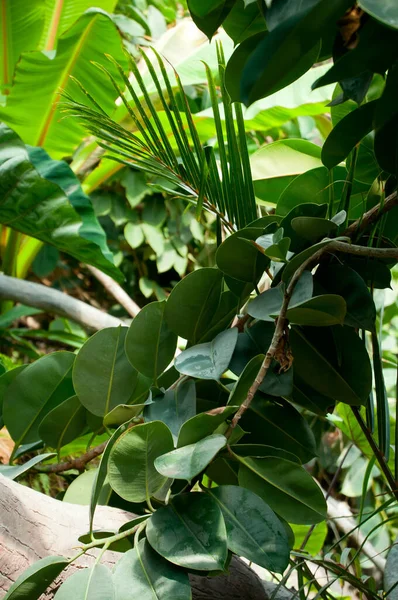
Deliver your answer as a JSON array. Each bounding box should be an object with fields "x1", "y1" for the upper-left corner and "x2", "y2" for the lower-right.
[{"x1": 54, "y1": 565, "x2": 115, "y2": 600}]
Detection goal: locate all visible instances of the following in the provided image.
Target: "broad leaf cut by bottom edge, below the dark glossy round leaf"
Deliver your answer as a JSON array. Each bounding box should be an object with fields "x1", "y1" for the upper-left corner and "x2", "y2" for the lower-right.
[{"x1": 113, "y1": 540, "x2": 191, "y2": 600}]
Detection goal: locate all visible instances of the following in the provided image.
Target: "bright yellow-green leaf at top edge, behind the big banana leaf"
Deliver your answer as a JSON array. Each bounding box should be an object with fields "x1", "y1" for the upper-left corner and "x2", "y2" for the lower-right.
[{"x1": 38, "y1": 0, "x2": 117, "y2": 50}]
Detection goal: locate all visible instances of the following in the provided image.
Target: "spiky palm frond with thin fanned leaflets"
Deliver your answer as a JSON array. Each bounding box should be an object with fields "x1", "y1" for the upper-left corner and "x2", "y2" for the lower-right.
[{"x1": 66, "y1": 45, "x2": 257, "y2": 231}]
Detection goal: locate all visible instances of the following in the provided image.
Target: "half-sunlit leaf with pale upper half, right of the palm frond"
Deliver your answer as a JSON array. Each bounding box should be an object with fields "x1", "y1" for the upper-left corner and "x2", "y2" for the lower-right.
[{"x1": 250, "y1": 139, "x2": 322, "y2": 204}]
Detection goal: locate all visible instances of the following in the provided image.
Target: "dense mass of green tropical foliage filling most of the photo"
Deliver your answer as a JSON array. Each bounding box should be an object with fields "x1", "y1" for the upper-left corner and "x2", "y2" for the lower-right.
[{"x1": 0, "y1": 0, "x2": 398, "y2": 600}]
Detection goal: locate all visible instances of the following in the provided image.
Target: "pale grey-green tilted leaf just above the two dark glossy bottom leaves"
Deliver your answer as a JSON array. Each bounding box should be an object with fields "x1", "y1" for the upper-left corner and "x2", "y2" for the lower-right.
[{"x1": 155, "y1": 434, "x2": 227, "y2": 481}]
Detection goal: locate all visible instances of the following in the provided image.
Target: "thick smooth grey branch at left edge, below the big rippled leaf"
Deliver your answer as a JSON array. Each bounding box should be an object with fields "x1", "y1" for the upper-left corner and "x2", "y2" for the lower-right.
[{"x1": 0, "y1": 275, "x2": 126, "y2": 330}]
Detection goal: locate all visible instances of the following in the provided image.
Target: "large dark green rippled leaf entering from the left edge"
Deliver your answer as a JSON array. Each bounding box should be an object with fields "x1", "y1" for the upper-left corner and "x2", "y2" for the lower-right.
[{"x1": 0, "y1": 125, "x2": 122, "y2": 280}]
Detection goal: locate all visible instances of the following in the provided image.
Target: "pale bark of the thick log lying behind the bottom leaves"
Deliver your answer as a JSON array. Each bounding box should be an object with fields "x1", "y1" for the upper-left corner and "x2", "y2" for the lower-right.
[{"x1": 0, "y1": 475, "x2": 276, "y2": 600}]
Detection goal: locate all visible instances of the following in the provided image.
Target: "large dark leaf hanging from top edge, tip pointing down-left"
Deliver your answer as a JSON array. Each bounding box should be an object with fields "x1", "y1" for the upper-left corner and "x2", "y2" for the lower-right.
[{"x1": 236, "y1": 0, "x2": 350, "y2": 104}]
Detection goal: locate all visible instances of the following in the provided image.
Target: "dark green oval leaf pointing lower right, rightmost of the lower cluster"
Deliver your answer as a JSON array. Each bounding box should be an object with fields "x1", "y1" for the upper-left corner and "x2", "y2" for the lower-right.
[{"x1": 238, "y1": 457, "x2": 326, "y2": 525}]
